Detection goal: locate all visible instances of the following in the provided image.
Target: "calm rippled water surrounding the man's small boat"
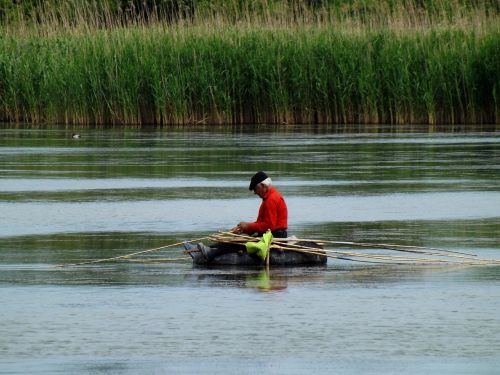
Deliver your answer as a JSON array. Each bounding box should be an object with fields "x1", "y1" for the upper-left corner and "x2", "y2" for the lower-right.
[{"x1": 0, "y1": 128, "x2": 500, "y2": 374}]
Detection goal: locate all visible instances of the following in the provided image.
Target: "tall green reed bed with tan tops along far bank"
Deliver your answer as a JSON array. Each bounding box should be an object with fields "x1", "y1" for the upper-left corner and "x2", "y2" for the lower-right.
[{"x1": 0, "y1": 1, "x2": 500, "y2": 125}]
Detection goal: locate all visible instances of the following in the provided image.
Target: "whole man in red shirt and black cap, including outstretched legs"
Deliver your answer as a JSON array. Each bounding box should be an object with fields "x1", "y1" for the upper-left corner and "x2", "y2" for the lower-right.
[{"x1": 198, "y1": 171, "x2": 288, "y2": 263}]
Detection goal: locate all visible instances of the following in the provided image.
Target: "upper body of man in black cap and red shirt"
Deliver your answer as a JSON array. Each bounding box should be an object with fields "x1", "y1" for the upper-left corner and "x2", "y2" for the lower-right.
[{"x1": 232, "y1": 171, "x2": 288, "y2": 238}]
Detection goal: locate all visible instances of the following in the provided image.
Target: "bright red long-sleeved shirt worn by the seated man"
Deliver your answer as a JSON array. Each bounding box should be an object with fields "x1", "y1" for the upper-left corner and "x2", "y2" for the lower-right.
[{"x1": 248, "y1": 186, "x2": 288, "y2": 233}]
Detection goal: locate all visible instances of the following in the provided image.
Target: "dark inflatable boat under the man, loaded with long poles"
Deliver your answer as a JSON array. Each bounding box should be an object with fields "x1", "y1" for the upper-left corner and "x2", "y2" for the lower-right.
[{"x1": 184, "y1": 242, "x2": 327, "y2": 266}]
